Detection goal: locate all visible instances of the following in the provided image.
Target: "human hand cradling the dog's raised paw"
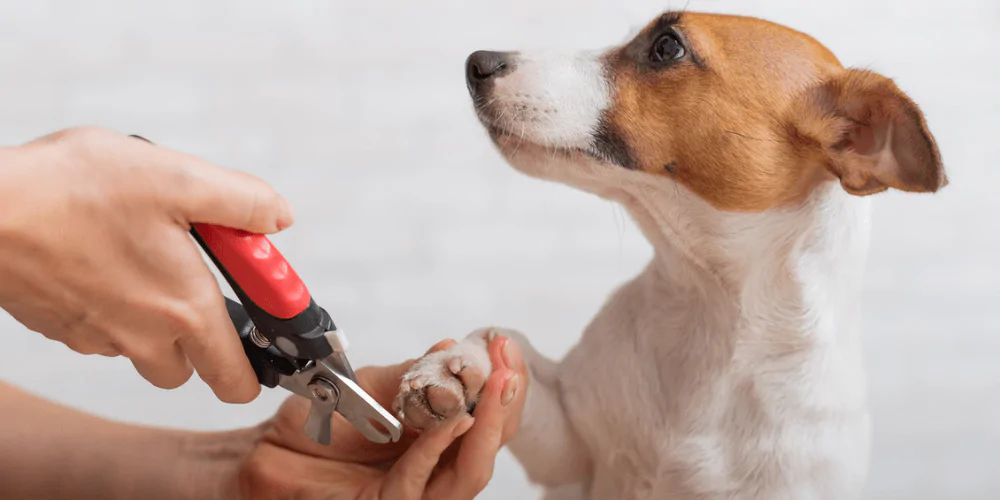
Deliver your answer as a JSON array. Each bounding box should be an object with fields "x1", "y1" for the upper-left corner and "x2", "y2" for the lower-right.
[{"x1": 238, "y1": 337, "x2": 528, "y2": 500}]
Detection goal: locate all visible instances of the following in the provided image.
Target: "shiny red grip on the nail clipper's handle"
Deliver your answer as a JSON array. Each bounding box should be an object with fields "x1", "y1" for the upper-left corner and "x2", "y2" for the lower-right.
[{"x1": 193, "y1": 223, "x2": 312, "y2": 319}]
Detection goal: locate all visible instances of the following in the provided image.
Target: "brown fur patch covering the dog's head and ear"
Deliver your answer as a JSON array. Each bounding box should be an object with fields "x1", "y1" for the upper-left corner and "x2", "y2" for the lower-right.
[{"x1": 606, "y1": 13, "x2": 946, "y2": 212}]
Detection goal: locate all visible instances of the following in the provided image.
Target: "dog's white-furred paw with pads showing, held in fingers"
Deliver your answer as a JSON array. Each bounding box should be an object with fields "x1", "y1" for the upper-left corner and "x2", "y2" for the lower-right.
[{"x1": 392, "y1": 329, "x2": 496, "y2": 430}]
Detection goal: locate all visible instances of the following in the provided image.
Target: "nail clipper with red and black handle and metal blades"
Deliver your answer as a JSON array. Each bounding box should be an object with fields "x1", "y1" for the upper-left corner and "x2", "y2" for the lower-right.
[{"x1": 133, "y1": 136, "x2": 402, "y2": 445}]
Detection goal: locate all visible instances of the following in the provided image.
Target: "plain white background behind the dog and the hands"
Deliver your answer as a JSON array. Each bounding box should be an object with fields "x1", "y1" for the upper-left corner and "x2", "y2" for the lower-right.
[{"x1": 0, "y1": 0, "x2": 1000, "y2": 500}]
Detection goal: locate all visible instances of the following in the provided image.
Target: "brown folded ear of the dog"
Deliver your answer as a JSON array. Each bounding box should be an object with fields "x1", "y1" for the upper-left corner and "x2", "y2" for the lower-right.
[{"x1": 792, "y1": 69, "x2": 948, "y2": 196}]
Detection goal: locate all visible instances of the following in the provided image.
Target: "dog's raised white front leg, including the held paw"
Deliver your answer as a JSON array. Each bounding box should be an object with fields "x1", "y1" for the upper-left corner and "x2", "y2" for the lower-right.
[{"x1": 393, "y1": 328, "x2": 590, "y2": 486}]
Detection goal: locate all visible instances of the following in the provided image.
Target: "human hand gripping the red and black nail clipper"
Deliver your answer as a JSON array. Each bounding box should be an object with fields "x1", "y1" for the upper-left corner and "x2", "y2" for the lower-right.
[{"x1": 0, "y1": 128, "x2": 293, "y2": 403}]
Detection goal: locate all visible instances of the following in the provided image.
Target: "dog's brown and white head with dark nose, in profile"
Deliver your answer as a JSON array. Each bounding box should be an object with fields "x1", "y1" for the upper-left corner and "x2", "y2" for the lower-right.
[{"x1": 466, "y1": 13, "x2": 947, "y2": 238}]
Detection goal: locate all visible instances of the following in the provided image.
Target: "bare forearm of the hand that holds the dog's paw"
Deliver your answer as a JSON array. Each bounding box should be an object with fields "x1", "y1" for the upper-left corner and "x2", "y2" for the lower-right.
[{"x1": 0, "y1": 382, "x2": 260, "y2": 499}]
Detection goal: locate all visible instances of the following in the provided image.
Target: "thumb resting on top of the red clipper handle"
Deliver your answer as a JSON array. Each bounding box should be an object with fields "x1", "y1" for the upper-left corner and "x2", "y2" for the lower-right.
[{"x1": 132, "y1": 141, "x2": 295, "y2": 234}]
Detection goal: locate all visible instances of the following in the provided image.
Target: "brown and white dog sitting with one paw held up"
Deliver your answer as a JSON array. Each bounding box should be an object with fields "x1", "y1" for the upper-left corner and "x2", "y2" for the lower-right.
[{"x1": 394, "y1": 12, "x2": 948, "y2": 500}]
